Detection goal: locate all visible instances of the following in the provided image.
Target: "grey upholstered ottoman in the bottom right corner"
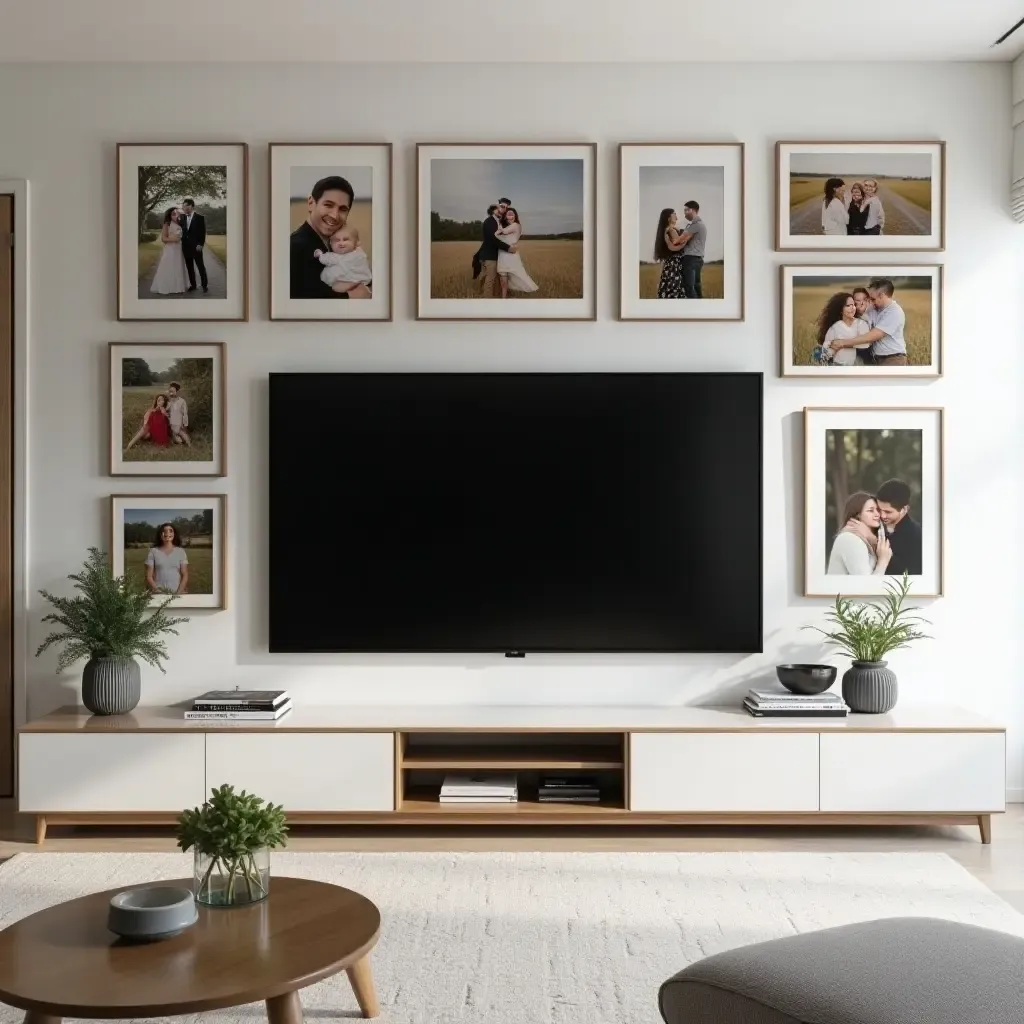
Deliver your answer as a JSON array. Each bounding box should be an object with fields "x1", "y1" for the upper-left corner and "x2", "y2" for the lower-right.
[{"x1": 658, "y1": 918, "x2": 1024, "y2": 1024}]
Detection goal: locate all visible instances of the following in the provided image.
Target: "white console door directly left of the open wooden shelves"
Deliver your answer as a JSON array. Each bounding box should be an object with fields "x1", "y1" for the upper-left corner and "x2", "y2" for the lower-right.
[{"x1": 206, "y1": 732, "x2": 394, "y2": 812}]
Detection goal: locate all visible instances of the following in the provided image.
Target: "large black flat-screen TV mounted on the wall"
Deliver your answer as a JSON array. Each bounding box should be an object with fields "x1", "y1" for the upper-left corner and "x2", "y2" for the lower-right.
[{"x1": 268, "y1": 373, "x2": 763, "y2": 654}]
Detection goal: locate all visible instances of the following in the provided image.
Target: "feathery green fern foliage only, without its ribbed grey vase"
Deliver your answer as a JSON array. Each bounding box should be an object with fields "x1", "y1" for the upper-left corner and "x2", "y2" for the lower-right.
[{"x1": 36, "y1": 548, "x2": 188, "y2": 674}]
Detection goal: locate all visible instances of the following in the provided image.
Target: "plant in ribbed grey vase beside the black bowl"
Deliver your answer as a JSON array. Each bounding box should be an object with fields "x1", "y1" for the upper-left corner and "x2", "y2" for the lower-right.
[{"x1": 808, "y1": 572, "x2": 931, "y2": 715}]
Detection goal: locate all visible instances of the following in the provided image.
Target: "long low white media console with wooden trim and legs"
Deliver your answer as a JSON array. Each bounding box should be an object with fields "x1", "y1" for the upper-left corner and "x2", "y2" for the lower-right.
[{"x1": 18, "y1": 706, "x2": 1006, "y2": 843}]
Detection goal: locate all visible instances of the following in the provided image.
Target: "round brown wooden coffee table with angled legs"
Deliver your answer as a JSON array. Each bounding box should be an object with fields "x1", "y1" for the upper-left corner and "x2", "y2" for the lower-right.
[{"x1": 0, "y1": 876, "x2": 381, "y2": 1024}]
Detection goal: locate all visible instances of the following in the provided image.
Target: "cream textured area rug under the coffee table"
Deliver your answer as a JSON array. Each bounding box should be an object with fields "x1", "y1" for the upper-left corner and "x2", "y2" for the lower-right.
[{"x1": 0, "y1": 853, "x2": 1024, "y2": 1024}]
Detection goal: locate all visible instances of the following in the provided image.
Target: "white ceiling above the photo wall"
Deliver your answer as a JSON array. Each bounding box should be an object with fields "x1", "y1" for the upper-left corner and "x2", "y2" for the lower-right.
[{"x1": 0, "y1": 0, "x2": 1024, "y2": 62}]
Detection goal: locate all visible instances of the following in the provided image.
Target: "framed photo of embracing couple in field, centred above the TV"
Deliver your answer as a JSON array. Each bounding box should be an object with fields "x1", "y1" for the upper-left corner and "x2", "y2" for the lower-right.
[{"x1": 416, "y1": 142, "x2": 597, "y2": 321}]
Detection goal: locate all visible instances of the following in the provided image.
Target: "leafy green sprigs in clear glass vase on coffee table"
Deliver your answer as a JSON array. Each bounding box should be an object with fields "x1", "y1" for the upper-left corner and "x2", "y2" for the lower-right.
[{"x1": 176, "y1": 783, "x2": 288, "y2": 906}]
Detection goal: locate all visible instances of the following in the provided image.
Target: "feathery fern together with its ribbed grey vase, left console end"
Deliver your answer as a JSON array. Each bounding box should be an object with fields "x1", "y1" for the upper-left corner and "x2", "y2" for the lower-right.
[{"x1": 36, "y1": 548, "x2": 188, "y2": 715}]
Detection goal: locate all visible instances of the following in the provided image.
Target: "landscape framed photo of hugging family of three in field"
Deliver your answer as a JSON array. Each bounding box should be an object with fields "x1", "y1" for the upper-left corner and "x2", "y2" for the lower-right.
[{"x1": 781, "y1": 265, "x2": 942, "y2": 379}]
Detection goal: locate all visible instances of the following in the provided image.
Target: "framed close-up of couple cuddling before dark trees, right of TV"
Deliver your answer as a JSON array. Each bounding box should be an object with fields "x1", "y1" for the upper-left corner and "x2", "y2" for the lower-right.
[{"x1": 804, "y1": 408, "x2": 943, "y2": 597}]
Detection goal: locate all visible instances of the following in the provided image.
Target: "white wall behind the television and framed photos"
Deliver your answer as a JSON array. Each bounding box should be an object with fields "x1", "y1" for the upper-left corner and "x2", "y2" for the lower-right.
[{"x1": 0, "y1": 65, "x2": 1024, "y2": 790}]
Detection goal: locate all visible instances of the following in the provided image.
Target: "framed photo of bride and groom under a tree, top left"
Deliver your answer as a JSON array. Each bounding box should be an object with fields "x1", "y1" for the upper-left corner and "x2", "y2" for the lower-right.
[{"x1": 117, "y1": 142, "x2": 249, "y2": 321}]
